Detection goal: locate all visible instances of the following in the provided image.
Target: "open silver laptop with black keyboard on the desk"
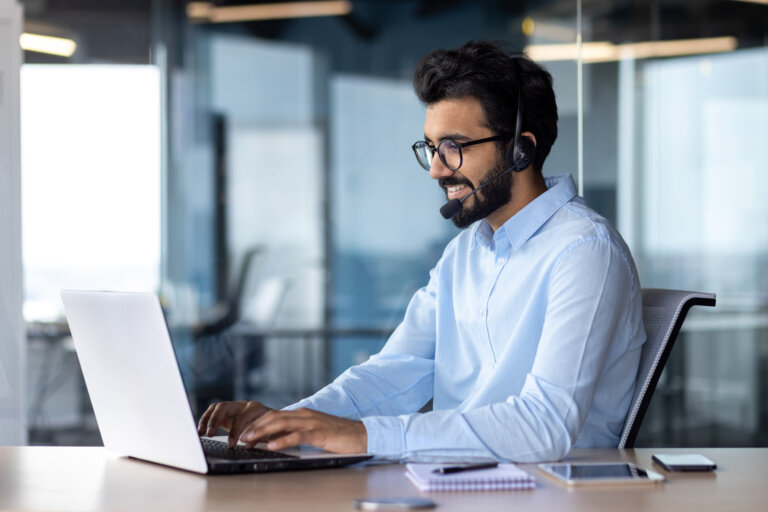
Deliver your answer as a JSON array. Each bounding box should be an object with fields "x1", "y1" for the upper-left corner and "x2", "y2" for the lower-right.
[{"x1": 61, "y1": 290, "x2": 372, "y2": 474}]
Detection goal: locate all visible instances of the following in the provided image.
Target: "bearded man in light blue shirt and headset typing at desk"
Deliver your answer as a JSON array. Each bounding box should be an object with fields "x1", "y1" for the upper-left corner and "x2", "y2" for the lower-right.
[{"x1": 199, "y1": 42, "x2": 645, "y2": 462}]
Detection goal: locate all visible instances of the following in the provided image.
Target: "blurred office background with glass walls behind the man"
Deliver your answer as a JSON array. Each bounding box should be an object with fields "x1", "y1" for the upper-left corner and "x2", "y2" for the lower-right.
[{"x1": 0, "y1": 0, "x2": 768, "y2": 446}]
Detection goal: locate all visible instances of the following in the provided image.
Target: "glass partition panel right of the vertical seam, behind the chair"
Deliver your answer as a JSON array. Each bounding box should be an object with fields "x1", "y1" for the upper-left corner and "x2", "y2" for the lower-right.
[{"x1": 583, "y1": 1, "x2": 768, "y2": 446}]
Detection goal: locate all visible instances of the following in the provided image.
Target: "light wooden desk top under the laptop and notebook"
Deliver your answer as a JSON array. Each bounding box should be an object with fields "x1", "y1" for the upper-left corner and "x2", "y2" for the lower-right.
[{"x1": 0, "y1": 447, "x2": 768, "y2": 512}]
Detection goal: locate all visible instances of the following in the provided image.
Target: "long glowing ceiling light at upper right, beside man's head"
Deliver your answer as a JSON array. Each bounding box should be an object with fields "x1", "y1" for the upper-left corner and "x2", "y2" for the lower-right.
[{"x1": 525, "y1": 36, "x2": 736, "y2": 63}]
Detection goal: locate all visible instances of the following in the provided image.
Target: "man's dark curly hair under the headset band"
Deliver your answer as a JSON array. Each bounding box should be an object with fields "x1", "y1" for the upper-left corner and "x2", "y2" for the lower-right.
[{"x1": 413, "y1": 41, "x2": 557, "y2": 172}]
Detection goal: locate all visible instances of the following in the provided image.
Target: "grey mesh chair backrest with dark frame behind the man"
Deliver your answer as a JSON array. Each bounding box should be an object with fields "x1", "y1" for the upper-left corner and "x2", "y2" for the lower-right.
[{"x1": 619, "y1": 288, "x2": 716, "y2": 448}]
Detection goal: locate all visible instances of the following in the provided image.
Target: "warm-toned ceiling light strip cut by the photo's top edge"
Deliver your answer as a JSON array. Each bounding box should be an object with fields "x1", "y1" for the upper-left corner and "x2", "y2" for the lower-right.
[{"x1": 187, "y1": 1, "x2": 352, "y2": 23}]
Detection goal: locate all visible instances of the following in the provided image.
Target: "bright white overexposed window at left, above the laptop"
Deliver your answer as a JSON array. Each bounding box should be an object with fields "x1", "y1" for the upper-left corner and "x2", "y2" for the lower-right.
[{"x1": 21, "y1": 64, "x2": 161, "y2": 321}]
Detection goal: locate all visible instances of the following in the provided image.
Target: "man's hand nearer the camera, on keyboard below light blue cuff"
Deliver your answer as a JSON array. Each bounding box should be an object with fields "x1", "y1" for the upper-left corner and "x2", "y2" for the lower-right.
[{"x1": 240, "y1": 408, "x2": 368, "y2": 453}]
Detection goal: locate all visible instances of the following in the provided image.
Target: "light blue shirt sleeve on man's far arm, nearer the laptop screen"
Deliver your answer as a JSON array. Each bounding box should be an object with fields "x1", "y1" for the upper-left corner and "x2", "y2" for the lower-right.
[{"x1": 286, "y1": 256, "x2": 440, "y2": 419}]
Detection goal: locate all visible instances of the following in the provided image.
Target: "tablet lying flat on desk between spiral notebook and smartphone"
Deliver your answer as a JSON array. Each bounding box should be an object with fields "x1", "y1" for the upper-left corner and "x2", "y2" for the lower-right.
[{"x1": 539, "y1": 462, "x2": 664, "y2": 485}]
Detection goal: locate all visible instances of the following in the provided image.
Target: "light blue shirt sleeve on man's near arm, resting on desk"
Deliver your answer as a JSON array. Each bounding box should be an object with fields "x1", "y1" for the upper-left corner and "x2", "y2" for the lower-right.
[{"x1": 363, "y1": 240, "x2": 642, "y2": 462}]
